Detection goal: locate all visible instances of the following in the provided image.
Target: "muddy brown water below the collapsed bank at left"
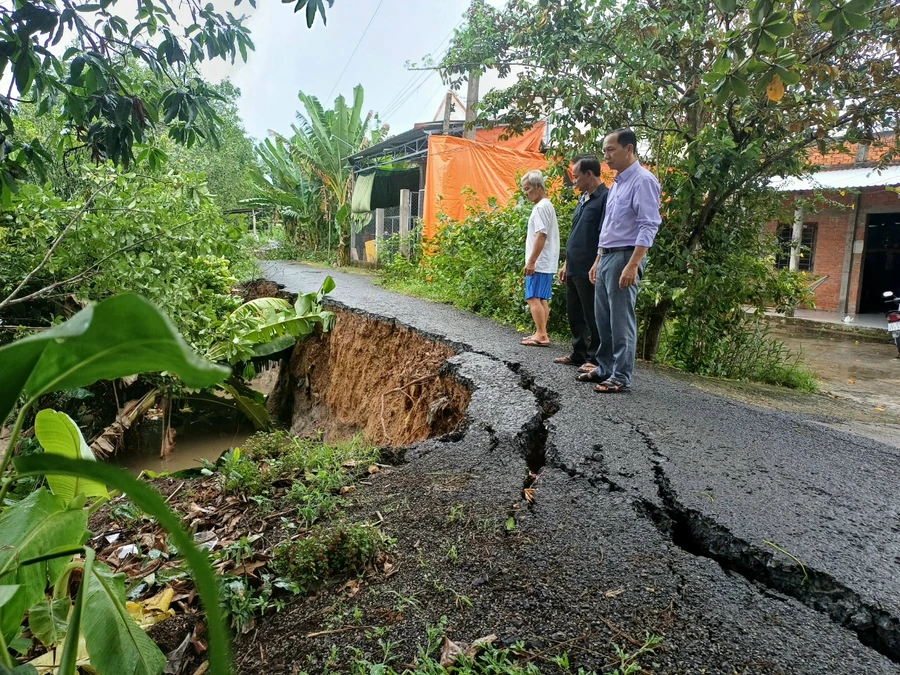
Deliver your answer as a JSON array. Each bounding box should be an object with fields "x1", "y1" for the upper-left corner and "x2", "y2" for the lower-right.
[{"x1": 119, "y1": 425, "x2": 252, "y2": 474}]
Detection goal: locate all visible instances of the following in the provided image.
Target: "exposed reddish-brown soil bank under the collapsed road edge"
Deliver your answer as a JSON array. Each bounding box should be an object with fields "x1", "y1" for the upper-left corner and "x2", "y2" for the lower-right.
[{"x1": 272, "y1": 310, "x2": 471, "y2": 446}]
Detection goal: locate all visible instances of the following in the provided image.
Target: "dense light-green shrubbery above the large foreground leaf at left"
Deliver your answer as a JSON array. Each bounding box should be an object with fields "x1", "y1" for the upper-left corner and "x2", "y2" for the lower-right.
[{"x1": 0, "y1": 166, "x2": 256, "y2": 351}]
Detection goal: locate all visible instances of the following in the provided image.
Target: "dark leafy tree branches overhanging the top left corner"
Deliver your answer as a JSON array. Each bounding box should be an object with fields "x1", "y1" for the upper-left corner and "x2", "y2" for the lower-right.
[{"x1": 0, "y1": 0, "x2": 334, "y2": 206}]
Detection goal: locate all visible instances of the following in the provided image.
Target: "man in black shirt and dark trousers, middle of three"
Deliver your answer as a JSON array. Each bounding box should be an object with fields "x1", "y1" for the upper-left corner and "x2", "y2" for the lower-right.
[{"x1": 553, "y1": 155, "x2": 607, "y2": 371}]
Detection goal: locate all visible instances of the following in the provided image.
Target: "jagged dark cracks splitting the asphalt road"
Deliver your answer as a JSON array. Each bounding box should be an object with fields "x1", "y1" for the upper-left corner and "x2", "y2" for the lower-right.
[{"x1": 278, "y1": 284, "x2": 900, "y2": 663}]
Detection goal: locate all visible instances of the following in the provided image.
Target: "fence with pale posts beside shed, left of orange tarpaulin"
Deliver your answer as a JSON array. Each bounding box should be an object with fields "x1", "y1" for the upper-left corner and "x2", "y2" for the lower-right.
[{"x1": 350, "y1": 190, "x2": 425, "y2": 267}]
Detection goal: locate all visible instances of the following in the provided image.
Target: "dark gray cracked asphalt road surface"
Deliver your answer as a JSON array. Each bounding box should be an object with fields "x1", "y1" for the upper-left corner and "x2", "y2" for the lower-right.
[{"x1": 262, "y1": 262, "x2": 900, "y2": 673}]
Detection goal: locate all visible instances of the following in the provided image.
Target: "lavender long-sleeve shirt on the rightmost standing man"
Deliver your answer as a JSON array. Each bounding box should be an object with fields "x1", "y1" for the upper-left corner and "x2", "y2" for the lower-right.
[{"x1": 597, "y1": 162, "x2": 662, "y2": 254}]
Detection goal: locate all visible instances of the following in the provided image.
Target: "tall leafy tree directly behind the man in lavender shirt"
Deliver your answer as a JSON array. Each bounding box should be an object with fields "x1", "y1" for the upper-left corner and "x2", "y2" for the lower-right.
[{"x1": 443, "y1": 0, "x2": 900, "y2": 368}]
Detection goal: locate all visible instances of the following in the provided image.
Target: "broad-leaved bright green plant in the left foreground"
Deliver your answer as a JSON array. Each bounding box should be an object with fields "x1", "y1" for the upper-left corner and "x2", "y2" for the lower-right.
[{"x1": 0, "y1": 295, "x2": 232, "y2": 675}]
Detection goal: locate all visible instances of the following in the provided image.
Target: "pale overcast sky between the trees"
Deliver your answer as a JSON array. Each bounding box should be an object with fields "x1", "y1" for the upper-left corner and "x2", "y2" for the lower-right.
[{"x1": 203, "y1": 0, "x2": 510, "y2": 140}]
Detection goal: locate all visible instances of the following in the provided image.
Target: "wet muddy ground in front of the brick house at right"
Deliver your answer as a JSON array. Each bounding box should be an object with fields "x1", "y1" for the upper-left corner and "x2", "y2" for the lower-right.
[{"x1": 771, "y1": 330, "x2": 900, "y2": 414}]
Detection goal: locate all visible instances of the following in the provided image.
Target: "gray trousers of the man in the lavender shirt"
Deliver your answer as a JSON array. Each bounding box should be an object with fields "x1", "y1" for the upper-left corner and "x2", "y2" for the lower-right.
[{"x1": 594, "y1": 251, "x2": 647, "y2": 386}]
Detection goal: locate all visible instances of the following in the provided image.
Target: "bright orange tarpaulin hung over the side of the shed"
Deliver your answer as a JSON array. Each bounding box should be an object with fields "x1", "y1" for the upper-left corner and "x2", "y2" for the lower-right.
[{"x1": 422, "y1": 126, "x2": 547, "y2": 239}]
